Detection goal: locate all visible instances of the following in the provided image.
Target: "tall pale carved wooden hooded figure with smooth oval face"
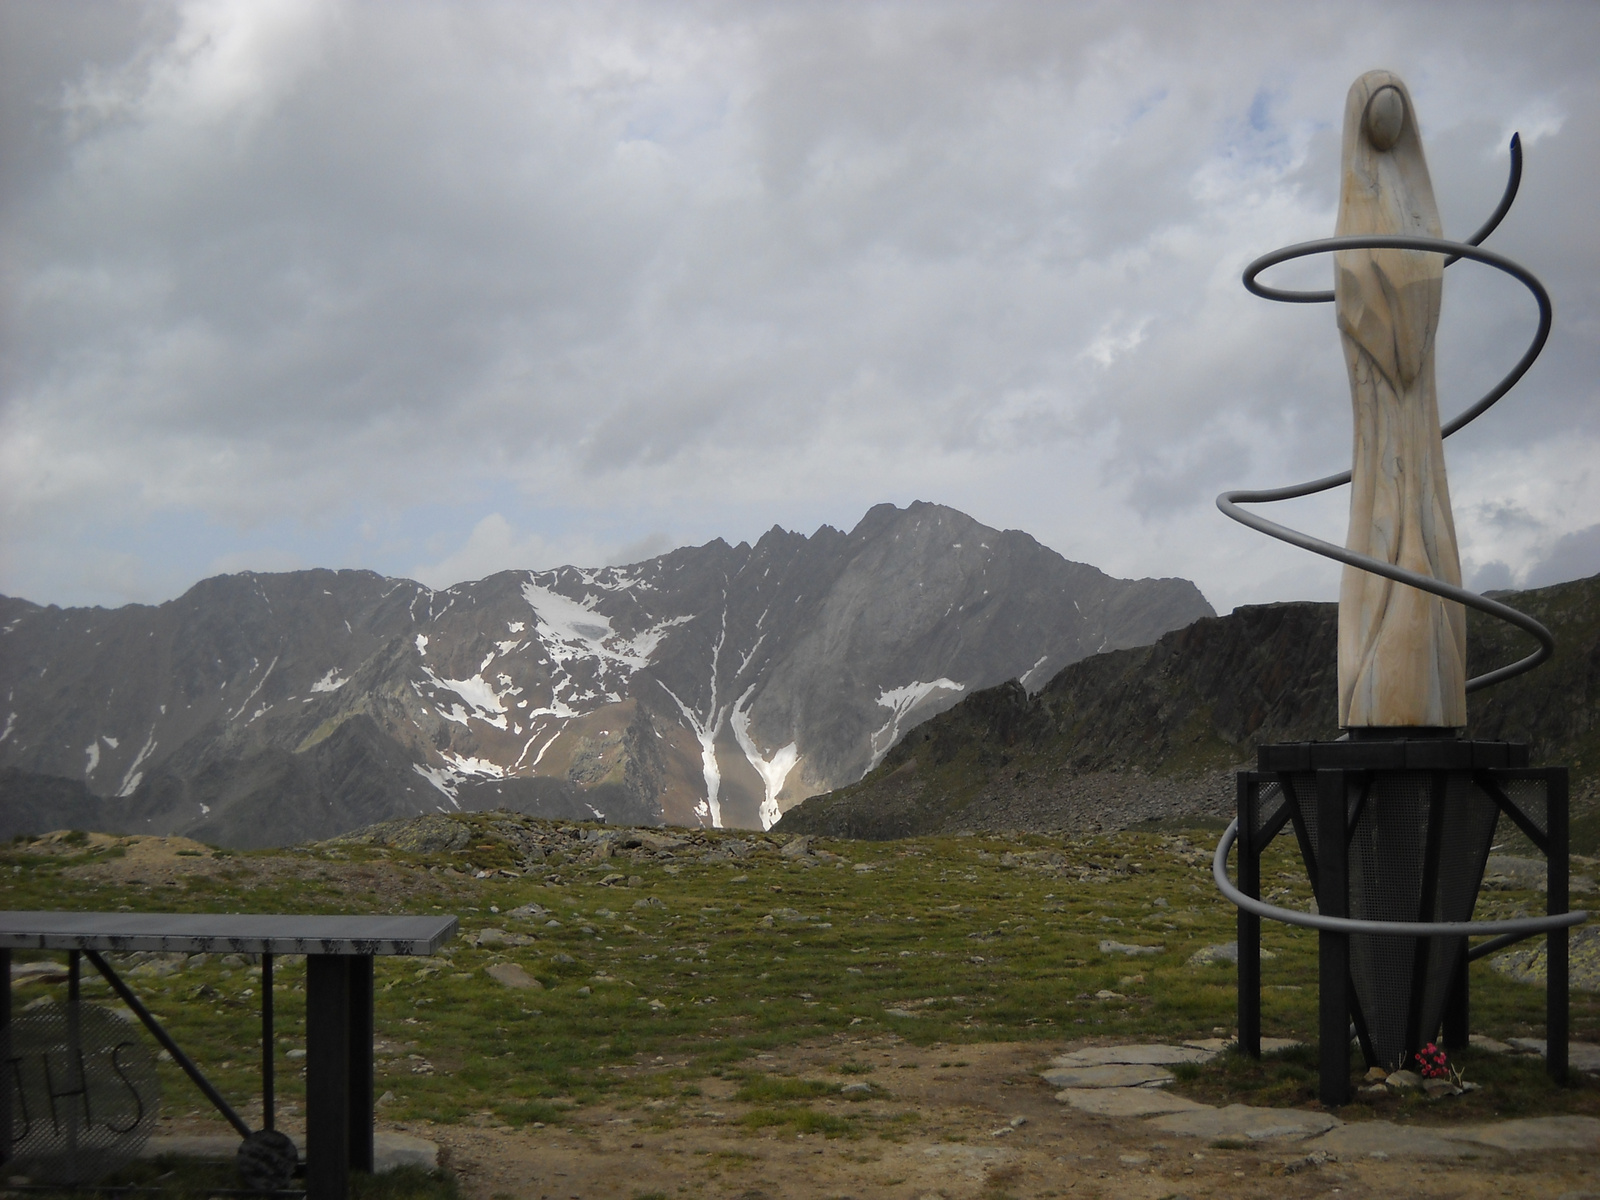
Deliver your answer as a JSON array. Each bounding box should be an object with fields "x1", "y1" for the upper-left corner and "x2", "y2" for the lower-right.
[{"x1": 1334, "y1": 70, "x2": 1467, "y2": 728}]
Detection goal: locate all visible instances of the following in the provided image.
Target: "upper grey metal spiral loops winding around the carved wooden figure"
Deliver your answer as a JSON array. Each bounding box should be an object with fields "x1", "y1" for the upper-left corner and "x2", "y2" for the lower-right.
[{"x1": 1216, "y1": 134, "x2": 1555, "y2": 691}]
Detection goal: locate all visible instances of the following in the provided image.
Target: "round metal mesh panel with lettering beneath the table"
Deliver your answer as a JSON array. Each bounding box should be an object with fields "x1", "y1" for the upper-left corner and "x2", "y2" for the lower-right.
[{"x1": 8, "y1": 1003, "x2": 160, "y2": 1184}]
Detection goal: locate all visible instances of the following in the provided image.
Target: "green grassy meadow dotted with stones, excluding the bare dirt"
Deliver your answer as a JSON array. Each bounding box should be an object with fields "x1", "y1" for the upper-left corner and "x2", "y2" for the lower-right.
[{"x1": 0, "y1": 814, "x2": 1600, "y2": 1139}]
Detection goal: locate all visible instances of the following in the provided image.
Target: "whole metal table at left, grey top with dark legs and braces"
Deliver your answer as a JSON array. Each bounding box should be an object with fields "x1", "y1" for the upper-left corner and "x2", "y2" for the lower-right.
[{"x1": 0, "y1": 912, "x2": 458, "y2": 1200}]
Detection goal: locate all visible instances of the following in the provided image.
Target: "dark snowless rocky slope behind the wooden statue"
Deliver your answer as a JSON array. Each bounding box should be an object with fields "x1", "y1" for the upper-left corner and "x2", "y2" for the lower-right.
[{"x1": 779, "y1": 576, "x2": 1600, "y2": 851}]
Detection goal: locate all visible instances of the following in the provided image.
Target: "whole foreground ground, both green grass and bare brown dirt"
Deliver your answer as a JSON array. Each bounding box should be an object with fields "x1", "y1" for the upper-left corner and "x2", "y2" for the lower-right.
[{"x1": 12, "y1": 813, "x2": 1600, "y2": 1200}]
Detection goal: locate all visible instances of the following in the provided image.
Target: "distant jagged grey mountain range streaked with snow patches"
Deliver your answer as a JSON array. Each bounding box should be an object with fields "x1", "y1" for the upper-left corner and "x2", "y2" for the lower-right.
[{"x1": 0, "y1": 504, "x2": 1211, "y2": 846}]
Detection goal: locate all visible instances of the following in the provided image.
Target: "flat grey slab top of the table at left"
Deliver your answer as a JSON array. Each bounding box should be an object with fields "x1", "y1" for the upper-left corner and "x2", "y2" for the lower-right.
[{"x1": 0, "y1": 912, "x2": 459, "y2": 954}]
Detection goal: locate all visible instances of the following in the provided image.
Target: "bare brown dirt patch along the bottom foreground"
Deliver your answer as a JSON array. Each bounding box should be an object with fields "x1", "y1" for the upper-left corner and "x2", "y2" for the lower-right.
[{"x1": 400, "y1": 1040, "x2": 1600, "y2": 1200}]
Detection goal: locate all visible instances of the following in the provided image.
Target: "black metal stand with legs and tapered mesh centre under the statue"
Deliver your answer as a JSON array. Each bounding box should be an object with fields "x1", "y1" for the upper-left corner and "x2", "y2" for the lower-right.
[{"x1": 1237, "y1": 738, "x2": 1568, "y2": 1106}]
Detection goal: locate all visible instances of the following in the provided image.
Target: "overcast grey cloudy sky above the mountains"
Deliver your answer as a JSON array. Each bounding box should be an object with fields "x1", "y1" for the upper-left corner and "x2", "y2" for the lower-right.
[{"x1": 0, "y1": 0, "x2": 1600, "y2": 611}]
